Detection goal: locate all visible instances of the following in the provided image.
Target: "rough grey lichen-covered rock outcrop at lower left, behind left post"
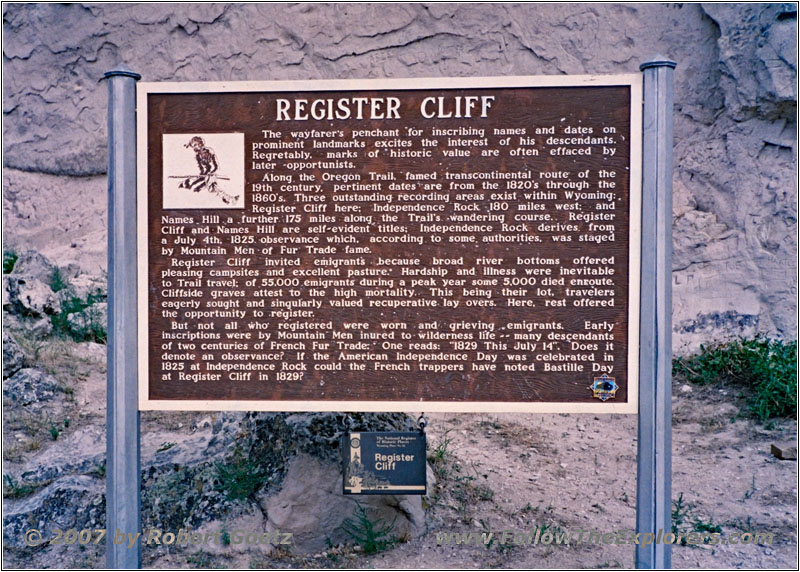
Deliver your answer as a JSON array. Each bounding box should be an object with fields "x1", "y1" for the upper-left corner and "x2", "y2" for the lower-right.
[{"x1": 3, "y1": 251, "x2": 425, "y2": 560}]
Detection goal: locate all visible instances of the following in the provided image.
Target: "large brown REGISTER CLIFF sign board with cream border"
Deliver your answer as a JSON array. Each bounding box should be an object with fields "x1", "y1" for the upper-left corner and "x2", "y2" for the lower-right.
[{"x1": 138, "y1": 75, "x2": 641, "y2": 413}]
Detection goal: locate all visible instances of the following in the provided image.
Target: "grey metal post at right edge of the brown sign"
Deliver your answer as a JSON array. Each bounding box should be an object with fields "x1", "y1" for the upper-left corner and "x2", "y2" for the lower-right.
[{"x1": 636, "y1": 57, "x2": 676, "y2": 569}]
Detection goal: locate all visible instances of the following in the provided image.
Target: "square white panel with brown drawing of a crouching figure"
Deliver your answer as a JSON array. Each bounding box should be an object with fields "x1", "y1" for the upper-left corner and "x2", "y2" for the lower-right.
[{"x1": 163, "y1": 133, "x2": 244, "y2": 209}]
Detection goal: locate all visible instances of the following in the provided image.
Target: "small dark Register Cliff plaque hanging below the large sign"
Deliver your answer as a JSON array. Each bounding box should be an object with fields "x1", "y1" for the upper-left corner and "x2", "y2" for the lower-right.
[{"x1": 342, "y1": 431, "x2": 427, "y2": 495}]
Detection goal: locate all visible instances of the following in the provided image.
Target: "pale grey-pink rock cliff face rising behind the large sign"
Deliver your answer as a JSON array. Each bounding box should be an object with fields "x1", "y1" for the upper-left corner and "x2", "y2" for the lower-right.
[{"x1": 3, "y1": 3, "x2": 797, "y2": 351}]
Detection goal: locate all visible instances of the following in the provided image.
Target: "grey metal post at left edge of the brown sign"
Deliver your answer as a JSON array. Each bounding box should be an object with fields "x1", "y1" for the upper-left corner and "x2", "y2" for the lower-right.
[{"x1": 104, "y1": 68, "x2": 142, "y2": 569}]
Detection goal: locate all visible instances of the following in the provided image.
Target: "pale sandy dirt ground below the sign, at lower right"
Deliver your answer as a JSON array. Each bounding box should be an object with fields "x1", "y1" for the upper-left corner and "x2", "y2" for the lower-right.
[{"x1": 151, "y1": 381, "x2": 798, "y2": 569}]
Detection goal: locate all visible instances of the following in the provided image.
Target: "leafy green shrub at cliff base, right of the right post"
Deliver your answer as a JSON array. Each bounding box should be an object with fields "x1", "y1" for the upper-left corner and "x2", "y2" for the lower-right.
[{"x1": 672, "y1": 336, "x2": 797, "y2": 423}]
